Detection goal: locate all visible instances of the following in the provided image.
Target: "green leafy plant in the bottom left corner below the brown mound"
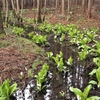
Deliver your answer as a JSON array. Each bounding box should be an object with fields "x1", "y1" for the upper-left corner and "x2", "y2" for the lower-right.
[{"x1": 0, "y1": 79, "x2": 18, "y2": 100}]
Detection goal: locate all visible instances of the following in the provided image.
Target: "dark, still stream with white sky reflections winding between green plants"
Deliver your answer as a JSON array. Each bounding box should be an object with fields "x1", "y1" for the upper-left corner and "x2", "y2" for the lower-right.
[{"x1": 15, "y1": 37, "x2": 100, "y2": 100}]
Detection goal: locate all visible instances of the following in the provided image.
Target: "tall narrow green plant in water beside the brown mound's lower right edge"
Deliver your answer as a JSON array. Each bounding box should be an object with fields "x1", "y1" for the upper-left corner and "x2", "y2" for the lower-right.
[{"x1": 35, "y1": 63, "x2": 49, "y2": 92}]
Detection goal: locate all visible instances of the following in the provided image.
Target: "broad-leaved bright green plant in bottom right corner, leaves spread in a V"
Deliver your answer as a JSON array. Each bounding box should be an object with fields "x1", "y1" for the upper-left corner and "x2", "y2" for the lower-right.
[{"x1": 69, "y1": 85, "x2": 100, "y2": 100}]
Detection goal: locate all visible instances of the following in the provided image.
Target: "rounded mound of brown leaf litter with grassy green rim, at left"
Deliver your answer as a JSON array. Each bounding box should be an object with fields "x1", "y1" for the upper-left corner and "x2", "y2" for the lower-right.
[{"x1": 0, "y1": 35, "x2": 44, "y2": 89}]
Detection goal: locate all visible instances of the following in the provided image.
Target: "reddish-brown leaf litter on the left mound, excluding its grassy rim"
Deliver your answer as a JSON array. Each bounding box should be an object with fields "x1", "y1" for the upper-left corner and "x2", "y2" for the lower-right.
[{"x1": 0, "y1": 35, "x2": 41, "y2": 89}]
